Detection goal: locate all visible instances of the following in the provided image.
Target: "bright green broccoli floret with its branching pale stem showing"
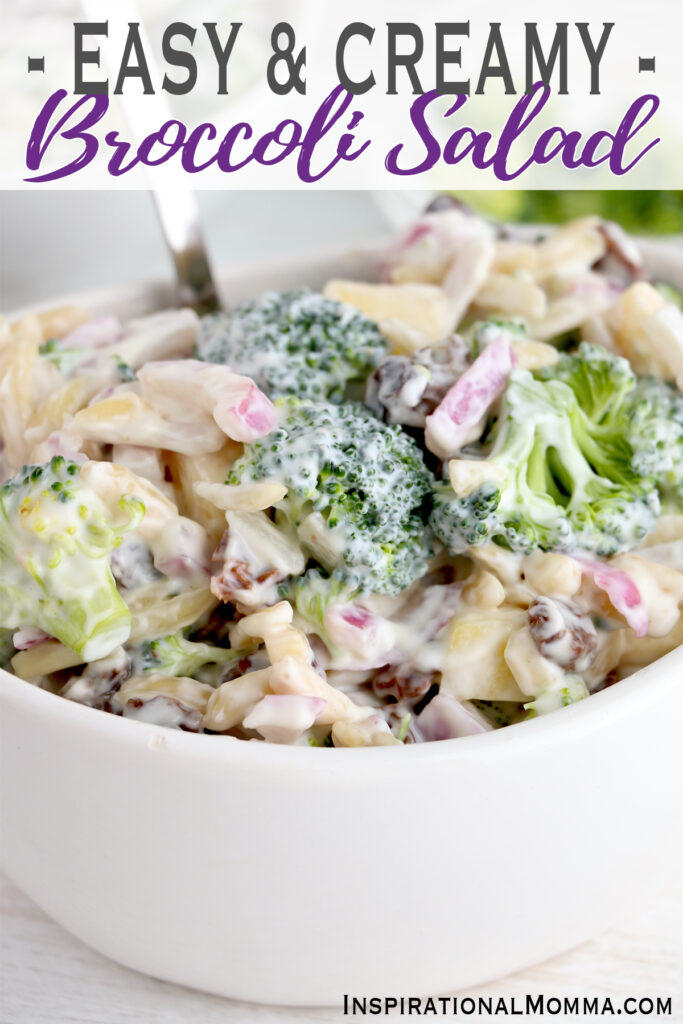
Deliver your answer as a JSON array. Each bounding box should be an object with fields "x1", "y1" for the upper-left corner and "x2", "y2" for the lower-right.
[{"x1": 431, "y1": 356, "x2": 660, "y2": 555}]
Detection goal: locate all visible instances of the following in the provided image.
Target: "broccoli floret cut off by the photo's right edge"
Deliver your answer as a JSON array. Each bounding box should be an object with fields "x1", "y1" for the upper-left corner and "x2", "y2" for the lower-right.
[{"x1": 629, "y1": 377, "x2": 683, "y2": 512}]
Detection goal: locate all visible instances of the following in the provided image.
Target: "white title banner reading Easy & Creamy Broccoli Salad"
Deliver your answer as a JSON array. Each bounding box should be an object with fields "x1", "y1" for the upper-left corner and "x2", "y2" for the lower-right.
[{"x1": 0, "y1": 0, "x2": 683, "y2": 189}]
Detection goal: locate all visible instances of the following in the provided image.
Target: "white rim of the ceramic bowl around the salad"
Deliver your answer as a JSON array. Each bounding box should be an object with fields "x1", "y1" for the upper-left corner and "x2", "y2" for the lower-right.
[{"x1": 5, "y1": 238, "x2": 683, "y2": 780}]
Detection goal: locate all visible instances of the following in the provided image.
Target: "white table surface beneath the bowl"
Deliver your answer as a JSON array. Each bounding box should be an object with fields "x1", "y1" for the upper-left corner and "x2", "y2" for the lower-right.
[{"x1": 0, "y1": 876, "x2": 683, "y2": 1024}]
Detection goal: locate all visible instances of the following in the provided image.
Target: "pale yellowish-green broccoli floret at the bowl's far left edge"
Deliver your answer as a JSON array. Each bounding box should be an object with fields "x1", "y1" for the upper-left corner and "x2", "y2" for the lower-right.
[{"x1": 0, "y1": 456, "x2": 144, "y2": 662}]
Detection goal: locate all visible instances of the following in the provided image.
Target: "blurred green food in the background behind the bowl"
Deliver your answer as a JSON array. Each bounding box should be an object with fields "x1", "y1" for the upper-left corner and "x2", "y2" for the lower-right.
[{"x1": 453, "y1": 189, "x2": 683, "y2": 234}]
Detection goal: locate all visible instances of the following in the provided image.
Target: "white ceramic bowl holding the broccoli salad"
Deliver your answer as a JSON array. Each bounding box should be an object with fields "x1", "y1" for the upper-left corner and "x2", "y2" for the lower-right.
[{"x1": 0, "y1": 241, "x2": 683, "y2": 1005}]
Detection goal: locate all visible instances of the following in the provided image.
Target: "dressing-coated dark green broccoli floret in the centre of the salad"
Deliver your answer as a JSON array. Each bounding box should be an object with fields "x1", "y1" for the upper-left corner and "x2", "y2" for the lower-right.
[{"x1": 227, "y1": 398, "x2": 433, "y2": 594}]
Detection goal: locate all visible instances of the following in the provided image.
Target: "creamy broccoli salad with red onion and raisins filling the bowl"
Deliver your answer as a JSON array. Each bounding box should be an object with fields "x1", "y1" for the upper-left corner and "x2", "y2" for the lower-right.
[{"x1": 0, "y1": 205, "x2": 683, "y2": 746}]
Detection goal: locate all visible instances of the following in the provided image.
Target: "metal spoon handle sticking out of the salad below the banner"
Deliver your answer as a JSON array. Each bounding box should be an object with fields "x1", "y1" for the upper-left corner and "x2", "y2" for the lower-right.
[{"x1": 153, "y1": 187, "x2": 224, "y2": 315}]
